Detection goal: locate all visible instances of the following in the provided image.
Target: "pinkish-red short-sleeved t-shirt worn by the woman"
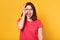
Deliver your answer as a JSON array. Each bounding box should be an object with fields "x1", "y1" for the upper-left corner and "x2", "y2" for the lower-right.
[{"x1": 18, "y1": 19, "x2": 43, "y2": 40}]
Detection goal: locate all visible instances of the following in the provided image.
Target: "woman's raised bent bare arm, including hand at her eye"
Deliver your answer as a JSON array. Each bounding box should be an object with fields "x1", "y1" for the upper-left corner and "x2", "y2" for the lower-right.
[{"x1": 17, "y1": 6, "x2": 27, "y2": 29}]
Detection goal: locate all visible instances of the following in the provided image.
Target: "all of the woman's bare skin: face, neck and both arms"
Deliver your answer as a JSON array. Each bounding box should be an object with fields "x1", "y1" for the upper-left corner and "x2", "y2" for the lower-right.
[{"x1": 17, "y1": 5, "x2": 43, "y2": 40}]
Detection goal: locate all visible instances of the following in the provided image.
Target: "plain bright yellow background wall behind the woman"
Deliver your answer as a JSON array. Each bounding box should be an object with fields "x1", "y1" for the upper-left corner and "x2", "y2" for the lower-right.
[{"x1": 0, "y1": 0, "x2": 60, "y2": 40}]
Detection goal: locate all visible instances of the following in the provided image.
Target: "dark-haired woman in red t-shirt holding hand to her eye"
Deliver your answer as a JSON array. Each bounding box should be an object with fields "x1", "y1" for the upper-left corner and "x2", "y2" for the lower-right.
[{"x1": 17, "y1": 2, "x2": 43, "y2": 40}]
